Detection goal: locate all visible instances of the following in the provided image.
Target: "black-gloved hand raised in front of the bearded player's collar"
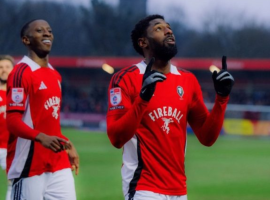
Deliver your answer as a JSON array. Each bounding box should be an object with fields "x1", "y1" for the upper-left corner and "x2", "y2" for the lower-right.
[{"x1": 140, "y1": 57, "x2": 166, "y2": 101}]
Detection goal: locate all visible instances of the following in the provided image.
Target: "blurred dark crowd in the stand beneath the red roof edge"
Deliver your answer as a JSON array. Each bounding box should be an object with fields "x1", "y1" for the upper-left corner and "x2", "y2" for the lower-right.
[{"x1": 59, "y1": 73, "x2": 270, "y2": 114}]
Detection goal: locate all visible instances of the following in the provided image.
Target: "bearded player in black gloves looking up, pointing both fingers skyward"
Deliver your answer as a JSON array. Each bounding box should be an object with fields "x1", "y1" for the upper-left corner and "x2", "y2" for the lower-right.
[{"x1": 107, "y1": 15, "x2": 234, "y2": 200}]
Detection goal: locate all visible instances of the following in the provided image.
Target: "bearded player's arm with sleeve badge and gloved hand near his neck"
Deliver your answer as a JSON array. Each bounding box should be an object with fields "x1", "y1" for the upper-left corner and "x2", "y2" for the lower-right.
[{"x1": 107, "y1": 58, "x2": 166, "y2": 148}]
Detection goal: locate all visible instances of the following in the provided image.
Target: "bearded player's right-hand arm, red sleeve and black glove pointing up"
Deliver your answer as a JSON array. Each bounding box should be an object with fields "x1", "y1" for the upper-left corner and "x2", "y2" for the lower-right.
[{"x1": 188, "y1": 56, "x2": 234, "y2": 146}]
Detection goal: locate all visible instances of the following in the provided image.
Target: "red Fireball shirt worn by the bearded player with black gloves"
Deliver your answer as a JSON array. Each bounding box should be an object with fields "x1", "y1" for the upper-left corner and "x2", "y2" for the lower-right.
[{"x1": 107, "y1": 62, "x2": 229, "y2": 195}]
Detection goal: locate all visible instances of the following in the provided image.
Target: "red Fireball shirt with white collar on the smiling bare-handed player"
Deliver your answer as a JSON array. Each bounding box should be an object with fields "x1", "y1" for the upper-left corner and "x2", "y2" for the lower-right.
[{"x1": 7, "y1": 56, "x2": 70, "y2": 179}]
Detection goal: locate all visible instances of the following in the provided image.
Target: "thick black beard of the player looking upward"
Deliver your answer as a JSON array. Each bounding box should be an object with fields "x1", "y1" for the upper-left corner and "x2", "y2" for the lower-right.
[{"x1": 148, "y1": 38, "x2": 177, "y2": 61}]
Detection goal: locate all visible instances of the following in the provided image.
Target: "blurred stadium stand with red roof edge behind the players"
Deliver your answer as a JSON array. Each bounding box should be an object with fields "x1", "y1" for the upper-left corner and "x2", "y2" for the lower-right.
[{"x1": 13, "y1": 57, "x2": 270, "y2": 132}]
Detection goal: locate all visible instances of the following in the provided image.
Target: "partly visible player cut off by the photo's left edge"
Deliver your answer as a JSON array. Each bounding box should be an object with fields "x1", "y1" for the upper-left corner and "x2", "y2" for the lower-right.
[{"x1": 0, "y1": 55, "x2": 14, "y2": 200}]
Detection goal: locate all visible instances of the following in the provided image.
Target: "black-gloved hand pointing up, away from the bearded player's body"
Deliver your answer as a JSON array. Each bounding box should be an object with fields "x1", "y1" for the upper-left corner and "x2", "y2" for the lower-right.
[{"x1": 212, "y1": 56, "x2": 234, "y2": 97}]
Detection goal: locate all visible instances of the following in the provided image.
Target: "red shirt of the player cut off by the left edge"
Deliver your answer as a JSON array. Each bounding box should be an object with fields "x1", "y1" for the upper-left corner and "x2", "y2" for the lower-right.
[{"x1": 0, "y1": 90, "x2": 8, "y2": 149}]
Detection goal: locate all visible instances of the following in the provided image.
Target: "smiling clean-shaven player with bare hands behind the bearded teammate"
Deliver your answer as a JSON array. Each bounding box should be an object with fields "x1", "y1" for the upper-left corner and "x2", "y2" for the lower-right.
[{"x1": 7, "y1": 19, "x2": 79, "y2": 200}]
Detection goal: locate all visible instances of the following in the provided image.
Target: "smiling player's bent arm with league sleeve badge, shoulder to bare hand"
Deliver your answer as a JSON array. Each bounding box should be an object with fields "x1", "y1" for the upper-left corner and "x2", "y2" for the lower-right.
[{"x1": 7, "y1": 64, "x2": 69, "y2": 152}]
